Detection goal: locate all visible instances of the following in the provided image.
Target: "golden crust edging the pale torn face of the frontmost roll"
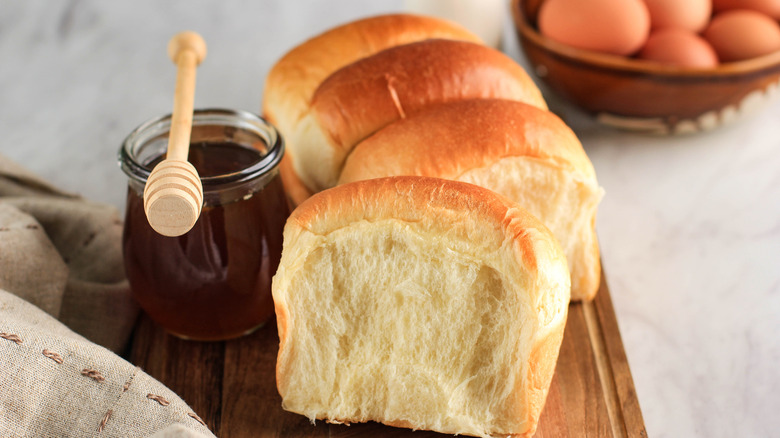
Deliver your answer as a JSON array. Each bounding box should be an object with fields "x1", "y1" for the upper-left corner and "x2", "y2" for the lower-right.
[{"x1": 274, "y1": 176, "x2": 569, "y2": 436}]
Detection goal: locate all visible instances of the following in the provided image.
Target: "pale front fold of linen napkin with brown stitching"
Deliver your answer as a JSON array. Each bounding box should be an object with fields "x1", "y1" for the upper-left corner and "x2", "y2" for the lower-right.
[{"x1": 0, "y1": 290, "x2": 214, "y2": 438}]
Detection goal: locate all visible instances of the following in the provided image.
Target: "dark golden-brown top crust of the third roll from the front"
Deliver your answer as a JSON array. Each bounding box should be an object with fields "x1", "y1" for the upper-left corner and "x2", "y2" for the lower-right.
[{"x1": 311, "y1": 40, "x2": 547, "y2": 159}]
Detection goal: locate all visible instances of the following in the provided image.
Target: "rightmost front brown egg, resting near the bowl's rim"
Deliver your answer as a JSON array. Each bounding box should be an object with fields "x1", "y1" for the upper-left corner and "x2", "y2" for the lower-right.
[{"x1": 703, "y1": 9, "x2": 780, "y2": 62}]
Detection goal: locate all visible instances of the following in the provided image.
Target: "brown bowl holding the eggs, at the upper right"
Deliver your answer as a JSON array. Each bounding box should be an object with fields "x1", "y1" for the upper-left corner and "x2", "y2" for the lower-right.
[{"x1": 512, "y1": 0, "x2": 780, "y2": 133}]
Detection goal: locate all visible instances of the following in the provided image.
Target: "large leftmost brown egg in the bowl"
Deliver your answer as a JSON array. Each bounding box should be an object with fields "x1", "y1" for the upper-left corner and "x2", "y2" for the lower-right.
[{"x1": 539, "y1": 0, "x2": 650, "y2": 55}]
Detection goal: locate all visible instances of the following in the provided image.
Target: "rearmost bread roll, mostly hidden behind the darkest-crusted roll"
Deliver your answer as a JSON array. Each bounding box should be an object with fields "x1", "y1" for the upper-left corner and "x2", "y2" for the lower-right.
[{"x1": 263, "y1": 14, "x2": 480, "y2": 204}]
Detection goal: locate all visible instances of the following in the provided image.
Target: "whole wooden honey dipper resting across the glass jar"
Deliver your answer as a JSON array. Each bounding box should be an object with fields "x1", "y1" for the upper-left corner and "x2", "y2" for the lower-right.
[{"x1": 144, "y1": 32, "x2": 206, "y2": 236}]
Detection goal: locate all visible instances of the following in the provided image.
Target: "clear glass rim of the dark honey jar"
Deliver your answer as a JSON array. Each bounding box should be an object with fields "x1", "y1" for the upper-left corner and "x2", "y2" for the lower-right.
[{"x1": 118, "y1": 108, "x2": 284, "y2": 190}]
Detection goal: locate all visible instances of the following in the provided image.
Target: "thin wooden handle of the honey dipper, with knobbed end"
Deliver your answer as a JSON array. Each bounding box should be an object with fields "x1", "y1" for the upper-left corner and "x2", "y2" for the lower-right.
[{"x1": 168, "y1": 32, "x2": 206, "y2": 161}]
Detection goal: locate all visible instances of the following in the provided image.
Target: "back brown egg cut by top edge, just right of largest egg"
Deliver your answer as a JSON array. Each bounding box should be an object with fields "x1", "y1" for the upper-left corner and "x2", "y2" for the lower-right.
[{"x1": 644, "y1": 0, "x2": 712, "y2": 32}]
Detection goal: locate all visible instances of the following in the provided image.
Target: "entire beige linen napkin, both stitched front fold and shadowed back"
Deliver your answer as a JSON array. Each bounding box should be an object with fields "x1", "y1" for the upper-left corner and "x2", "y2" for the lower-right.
[{"x1": 0, "y1": 155, "x2": 214, "y2": 438}]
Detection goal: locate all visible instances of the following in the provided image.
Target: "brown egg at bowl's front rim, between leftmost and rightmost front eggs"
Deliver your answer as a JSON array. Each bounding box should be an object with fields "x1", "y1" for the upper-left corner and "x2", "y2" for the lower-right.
[{"x1": 639, "y1": 28, "x2": 718, "y2": 68}]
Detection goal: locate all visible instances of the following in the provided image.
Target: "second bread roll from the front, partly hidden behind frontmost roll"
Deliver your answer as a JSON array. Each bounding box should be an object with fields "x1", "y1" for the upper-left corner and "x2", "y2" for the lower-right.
[{"x1": 339, "y1": 99, "x2": 602, "y2": 300}]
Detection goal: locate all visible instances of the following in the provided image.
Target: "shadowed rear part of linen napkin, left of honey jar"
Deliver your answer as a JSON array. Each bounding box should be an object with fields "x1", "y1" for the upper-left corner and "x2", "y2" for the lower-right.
[{"x1": 0, "y1": 155, "x2": 138, "y2": 351}]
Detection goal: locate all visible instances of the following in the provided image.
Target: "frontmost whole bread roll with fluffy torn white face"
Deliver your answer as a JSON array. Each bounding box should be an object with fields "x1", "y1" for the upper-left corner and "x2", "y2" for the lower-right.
[{"x1": 273, "y1": 177, "x2": 570, "y2": 437}]
